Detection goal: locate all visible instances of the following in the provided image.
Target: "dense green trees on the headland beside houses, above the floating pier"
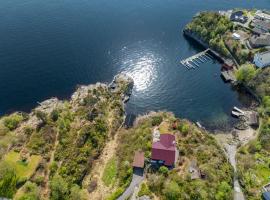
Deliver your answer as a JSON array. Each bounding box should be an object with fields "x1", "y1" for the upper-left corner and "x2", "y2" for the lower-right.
[{"x1": 184, "y1": 12, "x2": 256, "y2": 64}]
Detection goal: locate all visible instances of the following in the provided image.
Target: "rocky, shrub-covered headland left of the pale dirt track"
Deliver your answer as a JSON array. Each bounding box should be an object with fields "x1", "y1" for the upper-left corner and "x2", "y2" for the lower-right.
[{"x1": 0, "y1": 75, "x2": 133, "y2": 200}]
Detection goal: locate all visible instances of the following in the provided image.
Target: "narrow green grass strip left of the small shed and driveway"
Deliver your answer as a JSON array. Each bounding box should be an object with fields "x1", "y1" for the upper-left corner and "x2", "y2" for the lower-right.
[{"x1": 102, "y1": 157, "x2": 117, "y2": 186}]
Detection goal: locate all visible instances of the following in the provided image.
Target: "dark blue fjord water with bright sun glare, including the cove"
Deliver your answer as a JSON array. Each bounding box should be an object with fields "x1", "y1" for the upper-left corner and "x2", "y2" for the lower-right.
[{"x1": 0, "y1": 0, "x2": 270, "y2": 128}]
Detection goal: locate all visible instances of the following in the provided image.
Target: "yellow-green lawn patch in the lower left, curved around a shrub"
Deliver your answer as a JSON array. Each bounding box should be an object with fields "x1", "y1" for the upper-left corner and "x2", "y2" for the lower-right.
[{"x1": 4, "y1": 151, "x2": 41, "y2": 178}]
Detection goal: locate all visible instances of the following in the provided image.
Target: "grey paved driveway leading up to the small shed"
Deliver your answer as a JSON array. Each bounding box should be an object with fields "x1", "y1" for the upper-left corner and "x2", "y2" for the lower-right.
[{"x1": 117, "y1": 170, "x2": 144, "y2": 200}]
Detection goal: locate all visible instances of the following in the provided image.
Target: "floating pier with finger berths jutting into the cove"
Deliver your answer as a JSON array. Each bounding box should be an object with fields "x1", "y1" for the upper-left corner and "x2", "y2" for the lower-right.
[{"x1": 180, "y1": 49, "x2": 213, "y2": 69}]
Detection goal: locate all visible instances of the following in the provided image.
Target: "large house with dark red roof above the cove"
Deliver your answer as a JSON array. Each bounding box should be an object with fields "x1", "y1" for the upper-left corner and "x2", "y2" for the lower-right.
[{"x1": 152, "y1": 134, "x2": 176, "y2": 166}]
